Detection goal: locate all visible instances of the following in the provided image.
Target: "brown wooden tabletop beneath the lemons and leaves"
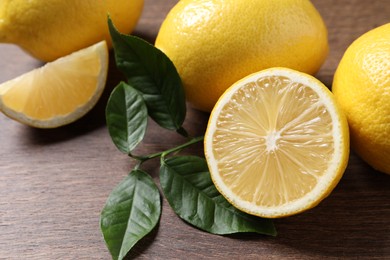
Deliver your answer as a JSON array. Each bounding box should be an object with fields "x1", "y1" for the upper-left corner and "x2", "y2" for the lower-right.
[{"x1": 0, "y1": 0, "x2": 390, "y2": 259}]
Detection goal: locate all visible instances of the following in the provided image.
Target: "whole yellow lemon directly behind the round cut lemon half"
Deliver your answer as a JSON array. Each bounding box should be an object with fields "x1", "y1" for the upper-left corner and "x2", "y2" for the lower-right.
[{"x1": 155, "y1": 0, "x2": 328, "y2": 111}]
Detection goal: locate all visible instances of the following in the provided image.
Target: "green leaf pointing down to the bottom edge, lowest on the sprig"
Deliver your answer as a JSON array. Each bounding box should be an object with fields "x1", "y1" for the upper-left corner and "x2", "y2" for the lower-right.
[{"x1": 100, "y1": 170, "x2": 161, "y2": 259}]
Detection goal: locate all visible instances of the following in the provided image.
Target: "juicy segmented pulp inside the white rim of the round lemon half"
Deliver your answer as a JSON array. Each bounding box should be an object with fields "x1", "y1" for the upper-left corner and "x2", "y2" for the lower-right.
[{"x1": 213, "y1": 77, "x2": 333, "y2": 206}]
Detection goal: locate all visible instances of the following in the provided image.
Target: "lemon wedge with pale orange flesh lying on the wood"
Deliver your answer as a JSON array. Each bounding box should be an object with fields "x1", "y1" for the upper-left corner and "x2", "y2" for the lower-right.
[{"x1": 0, "y1": 41, "x2": 108, "y2": 128}]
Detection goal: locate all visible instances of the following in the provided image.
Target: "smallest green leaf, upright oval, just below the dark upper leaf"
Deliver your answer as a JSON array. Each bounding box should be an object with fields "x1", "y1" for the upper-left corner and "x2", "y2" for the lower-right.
[{"x1": 106, "y1": 82, "x2": 148, "y2": 154}]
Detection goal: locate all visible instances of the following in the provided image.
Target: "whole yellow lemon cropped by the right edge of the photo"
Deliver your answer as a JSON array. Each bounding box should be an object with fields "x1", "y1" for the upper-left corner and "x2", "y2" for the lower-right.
[{"x1": 332, "y1": 23, "x2": 390, "y2": 174}]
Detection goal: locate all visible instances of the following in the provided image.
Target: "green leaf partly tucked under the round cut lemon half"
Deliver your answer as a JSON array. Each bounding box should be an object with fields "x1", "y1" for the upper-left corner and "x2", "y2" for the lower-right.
[{"x1": 160, "y1": 156, "x2": 276, "y2": 236}]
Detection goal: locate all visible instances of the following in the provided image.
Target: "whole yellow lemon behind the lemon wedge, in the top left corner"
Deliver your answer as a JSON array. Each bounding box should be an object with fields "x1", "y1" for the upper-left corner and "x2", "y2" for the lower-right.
[{"x1": 0, "y1": 0, "x2": 144, "y2": 61}]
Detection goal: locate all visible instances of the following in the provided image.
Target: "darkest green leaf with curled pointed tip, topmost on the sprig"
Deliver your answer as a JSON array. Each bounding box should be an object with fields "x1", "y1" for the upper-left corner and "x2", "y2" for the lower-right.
[{"x1": 108, "y1": 18, "x2": 186, "y2": 130}]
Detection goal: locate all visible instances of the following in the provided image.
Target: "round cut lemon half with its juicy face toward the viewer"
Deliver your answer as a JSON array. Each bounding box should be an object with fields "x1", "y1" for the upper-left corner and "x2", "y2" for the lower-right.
[{"x1": 205, "y1": 68, "x2": 349, "y2": 218}]
